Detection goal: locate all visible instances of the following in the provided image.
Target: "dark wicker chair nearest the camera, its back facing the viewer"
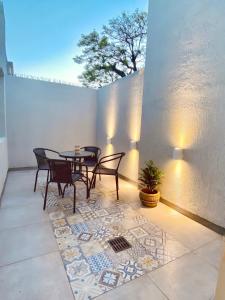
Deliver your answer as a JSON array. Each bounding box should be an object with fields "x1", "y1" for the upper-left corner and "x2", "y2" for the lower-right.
[{"x1": 43, "y1": 159, "x2": 89, "y2": 213}]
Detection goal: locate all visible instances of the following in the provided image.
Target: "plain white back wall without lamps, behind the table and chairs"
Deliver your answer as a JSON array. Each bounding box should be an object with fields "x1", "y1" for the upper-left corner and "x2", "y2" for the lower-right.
[{"x1": 6, "y1": 76, "x2": 96, "y2": 168}]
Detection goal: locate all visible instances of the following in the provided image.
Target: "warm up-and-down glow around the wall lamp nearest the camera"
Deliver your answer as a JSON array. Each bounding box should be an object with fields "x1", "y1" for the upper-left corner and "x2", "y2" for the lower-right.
[{"x1": 162, "y1": 49, "x2": 206, "y2": 209}]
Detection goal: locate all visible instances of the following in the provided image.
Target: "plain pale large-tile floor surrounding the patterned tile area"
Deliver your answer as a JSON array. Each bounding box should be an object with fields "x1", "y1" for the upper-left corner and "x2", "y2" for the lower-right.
[{"x1": 0, "y1": 171, "x2": 224, "y2": 300}]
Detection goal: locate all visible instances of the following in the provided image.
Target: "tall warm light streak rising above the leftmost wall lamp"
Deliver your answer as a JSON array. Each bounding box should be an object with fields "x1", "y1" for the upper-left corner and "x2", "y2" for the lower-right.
[{"x1": 106, "y1": 84, "x2": 118, "y2": 138}]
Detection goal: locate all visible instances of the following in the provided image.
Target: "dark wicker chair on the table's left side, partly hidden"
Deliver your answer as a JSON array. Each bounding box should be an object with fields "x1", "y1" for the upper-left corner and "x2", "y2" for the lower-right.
[{"x1": 33, "y1": 148, "x2": 59, "y2": 192}]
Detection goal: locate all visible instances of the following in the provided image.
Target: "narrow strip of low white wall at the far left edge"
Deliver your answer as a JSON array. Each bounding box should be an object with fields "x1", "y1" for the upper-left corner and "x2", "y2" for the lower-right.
[{"x1": 0, "y1": 137, "x2": 8, "y2": 195}]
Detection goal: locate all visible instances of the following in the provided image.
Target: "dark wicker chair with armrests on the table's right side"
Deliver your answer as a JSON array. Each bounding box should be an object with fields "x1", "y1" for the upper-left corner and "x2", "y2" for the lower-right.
[{"x1": 90, "y1": 152, "x2": 125, "y2": 200}]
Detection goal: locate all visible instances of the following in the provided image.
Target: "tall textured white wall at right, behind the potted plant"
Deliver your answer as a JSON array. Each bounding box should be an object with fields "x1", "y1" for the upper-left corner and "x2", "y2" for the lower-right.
[{"x1": 140, "y1": 0, "x2": 225, "y2": 226}]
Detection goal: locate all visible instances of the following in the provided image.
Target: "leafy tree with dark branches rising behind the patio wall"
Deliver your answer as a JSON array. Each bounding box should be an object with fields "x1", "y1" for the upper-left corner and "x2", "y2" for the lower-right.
[{"x1": 74, "y1": 9, "x2": 147, "y2": 87}]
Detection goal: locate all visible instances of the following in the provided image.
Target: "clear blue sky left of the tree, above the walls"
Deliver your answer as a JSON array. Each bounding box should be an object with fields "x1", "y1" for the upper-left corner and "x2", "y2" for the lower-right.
[{"x1": 3, "y1": 0, "x2": 148, "y2": 84}]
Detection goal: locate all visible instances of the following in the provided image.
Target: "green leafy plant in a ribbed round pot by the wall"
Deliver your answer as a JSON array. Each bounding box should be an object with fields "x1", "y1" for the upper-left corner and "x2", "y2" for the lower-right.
[{"x1": 139, "y1": 160, "x2": 163, "y2": 207}]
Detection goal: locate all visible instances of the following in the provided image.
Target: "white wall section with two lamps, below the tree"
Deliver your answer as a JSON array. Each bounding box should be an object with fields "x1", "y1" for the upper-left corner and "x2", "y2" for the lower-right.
[{"x1": 97, "y1": 71, "x2": 143, "y2": 181}]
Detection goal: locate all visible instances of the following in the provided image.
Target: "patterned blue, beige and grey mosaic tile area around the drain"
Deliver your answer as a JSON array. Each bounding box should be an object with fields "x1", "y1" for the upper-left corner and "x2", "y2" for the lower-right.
[{"x1": 40, "y1": 179, "x2": 189, "y2": 300}]
